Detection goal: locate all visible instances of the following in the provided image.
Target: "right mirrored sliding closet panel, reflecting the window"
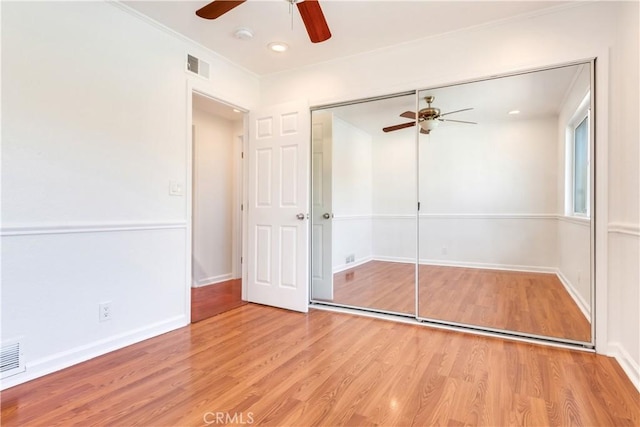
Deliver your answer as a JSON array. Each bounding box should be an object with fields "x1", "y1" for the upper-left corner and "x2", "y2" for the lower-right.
[{"x1": 418, "y1": 63, "x2": 593, "y2": 342}]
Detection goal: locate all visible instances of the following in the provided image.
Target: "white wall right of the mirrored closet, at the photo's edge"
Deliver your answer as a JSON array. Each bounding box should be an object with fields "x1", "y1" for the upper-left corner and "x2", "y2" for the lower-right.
[{"x1": 596, "y1": 2, "x2": 640, "y2": 390}]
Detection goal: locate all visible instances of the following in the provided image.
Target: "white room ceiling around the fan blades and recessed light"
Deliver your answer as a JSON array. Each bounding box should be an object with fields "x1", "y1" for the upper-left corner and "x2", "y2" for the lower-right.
[{"x1": 122, "y1": 0, "x2": 568, "y2": 75}]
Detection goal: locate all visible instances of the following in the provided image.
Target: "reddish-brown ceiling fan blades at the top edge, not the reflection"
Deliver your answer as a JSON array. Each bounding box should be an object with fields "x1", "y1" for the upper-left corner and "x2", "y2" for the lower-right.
[{"x1": 196, "y1": 0, "x2": 331, "y2": 43}]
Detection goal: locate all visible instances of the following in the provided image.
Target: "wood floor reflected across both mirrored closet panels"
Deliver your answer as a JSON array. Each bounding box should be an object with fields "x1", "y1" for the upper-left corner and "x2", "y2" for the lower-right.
[{"x1": 333, "y1": 261, "x2": 591, "y2": 341}]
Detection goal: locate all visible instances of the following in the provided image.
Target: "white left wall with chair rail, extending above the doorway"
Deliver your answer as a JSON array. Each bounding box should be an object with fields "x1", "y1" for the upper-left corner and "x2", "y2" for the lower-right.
[{"x1": 1, "y1": 2, "x2": 259, "y2": 387}]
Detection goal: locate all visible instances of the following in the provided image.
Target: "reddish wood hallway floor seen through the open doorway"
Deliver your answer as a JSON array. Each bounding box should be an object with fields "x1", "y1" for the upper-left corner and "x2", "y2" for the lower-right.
[{"x1": 191, "y1": 279, "x2": 246, "y2": 323}]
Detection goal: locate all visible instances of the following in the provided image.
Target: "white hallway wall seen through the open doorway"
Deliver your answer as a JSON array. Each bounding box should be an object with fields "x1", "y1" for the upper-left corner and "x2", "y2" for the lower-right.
[{"x1": 192, "y1": 108, "x2": 238, "y2": 287}]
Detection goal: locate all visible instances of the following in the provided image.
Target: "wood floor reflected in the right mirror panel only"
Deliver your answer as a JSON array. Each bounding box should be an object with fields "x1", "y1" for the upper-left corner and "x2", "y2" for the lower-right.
[{"x1": 419, "y1": 265, "x2": 591, "y2": 341}]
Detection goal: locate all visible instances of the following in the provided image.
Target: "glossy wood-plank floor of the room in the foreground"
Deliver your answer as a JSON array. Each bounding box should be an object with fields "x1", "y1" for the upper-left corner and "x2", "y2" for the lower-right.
[{"x1": 1, "y1": 304, "x2": 640, "y2": 427}]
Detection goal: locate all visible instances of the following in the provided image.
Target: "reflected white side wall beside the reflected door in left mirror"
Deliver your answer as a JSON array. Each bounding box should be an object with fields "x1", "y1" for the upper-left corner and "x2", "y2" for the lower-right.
[{"x1": 332, "y1": 115, "x2": 373, "y2": 271}]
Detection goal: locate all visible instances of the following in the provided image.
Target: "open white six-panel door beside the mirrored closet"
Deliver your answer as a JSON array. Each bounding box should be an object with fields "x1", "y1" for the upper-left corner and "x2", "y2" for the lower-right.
[{"x1": 247, "y1": 103, "x2": 311, "y2": 312}]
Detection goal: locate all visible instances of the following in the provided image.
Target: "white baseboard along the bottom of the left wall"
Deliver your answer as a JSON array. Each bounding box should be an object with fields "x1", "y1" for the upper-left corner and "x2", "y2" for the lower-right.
[{"x1": 0, "y1": 314, "x2": 191, "y2": 390}]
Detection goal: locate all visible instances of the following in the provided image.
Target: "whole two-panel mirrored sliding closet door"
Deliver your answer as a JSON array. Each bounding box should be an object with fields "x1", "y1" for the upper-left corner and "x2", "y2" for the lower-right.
[{"x1": 311, "y1": 62, "x2": 595, "y2": 346}]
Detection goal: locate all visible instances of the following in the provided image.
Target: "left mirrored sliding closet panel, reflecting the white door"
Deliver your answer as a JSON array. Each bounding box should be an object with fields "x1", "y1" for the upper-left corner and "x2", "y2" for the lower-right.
[{"x1": 311, "y1": 94, "x2": 417, "y2": 315}]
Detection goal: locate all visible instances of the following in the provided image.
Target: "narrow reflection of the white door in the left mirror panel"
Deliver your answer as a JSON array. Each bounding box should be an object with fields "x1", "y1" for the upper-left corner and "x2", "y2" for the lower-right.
[{"x1": 311, "y1": 111, "x2": 333, "y2": 300}]
